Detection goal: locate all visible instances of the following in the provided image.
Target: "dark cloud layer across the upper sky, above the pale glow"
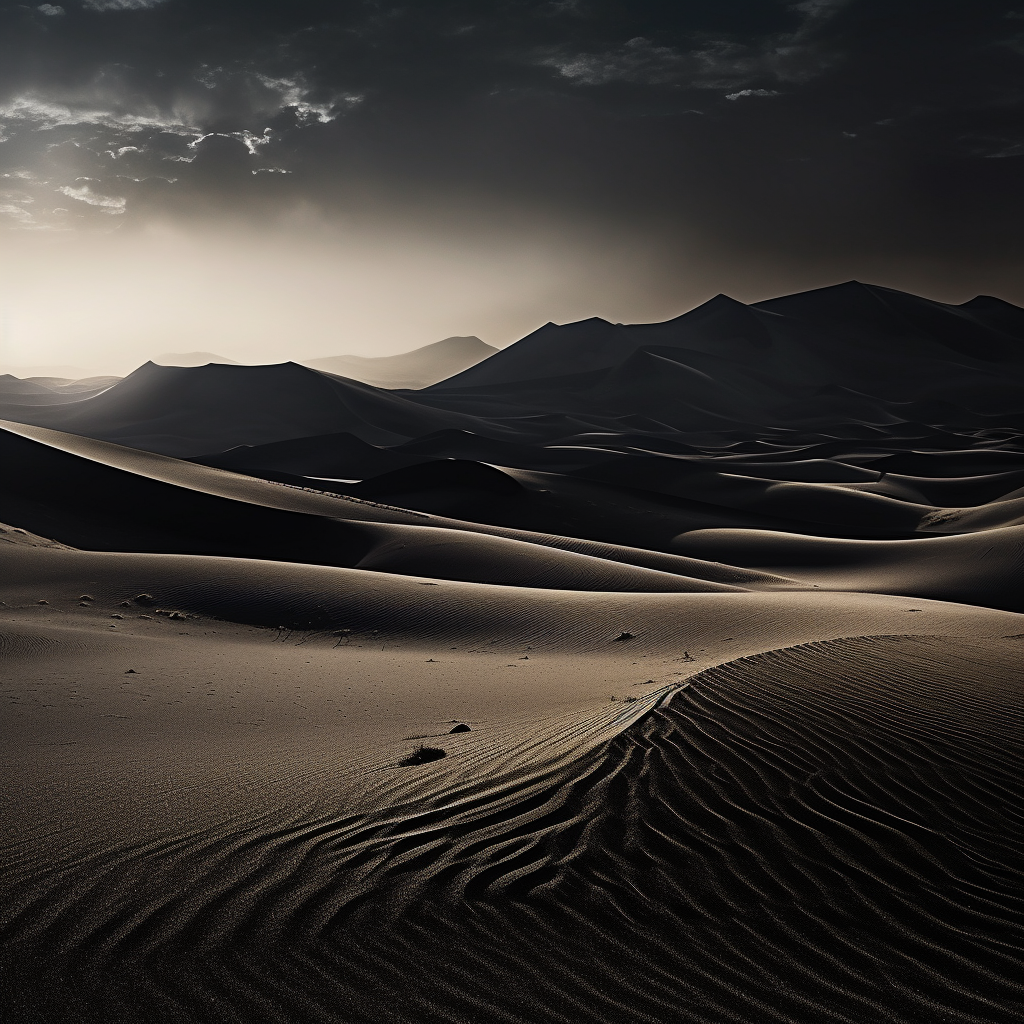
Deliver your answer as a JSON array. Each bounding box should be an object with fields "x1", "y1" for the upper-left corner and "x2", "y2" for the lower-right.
[{"x1": 0, "y1": 0, "x2": 1024, "y2": 299}]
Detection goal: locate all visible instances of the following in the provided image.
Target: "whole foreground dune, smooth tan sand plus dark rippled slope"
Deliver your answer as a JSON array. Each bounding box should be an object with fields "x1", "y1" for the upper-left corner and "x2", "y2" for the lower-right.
[{"x1": 0, "y1": 549, "x2": 1024, "y2": 1021}]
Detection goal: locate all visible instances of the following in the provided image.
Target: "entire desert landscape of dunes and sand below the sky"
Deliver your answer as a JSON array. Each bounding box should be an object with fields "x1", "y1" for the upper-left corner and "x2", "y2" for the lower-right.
[{"x1": 0, "y1": 283, "x2": 1024, "y2": 1024}]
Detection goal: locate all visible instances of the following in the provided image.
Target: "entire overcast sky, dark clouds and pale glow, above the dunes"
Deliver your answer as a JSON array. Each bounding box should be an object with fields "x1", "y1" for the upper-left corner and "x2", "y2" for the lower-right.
[{"x1": 0, "y1": 0, "x2": 1024, "y2": 370}]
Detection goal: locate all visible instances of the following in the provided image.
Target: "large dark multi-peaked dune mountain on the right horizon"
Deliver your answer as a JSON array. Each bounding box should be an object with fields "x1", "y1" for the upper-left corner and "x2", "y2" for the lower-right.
[{"x1": 417, "y1": 282, "x2": 1024, "y2": 436}]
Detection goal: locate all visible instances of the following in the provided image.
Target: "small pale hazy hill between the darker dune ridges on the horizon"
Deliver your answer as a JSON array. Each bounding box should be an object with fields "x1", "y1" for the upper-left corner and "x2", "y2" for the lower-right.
[{"x1": 301, "y1": 336, "x2": 498, "y2": 390}]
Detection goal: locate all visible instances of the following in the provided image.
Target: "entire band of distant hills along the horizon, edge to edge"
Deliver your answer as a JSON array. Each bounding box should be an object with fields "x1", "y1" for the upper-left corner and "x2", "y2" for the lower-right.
[{"x1": 0, "y1": 282, "x2": 1024, "y2": 456}]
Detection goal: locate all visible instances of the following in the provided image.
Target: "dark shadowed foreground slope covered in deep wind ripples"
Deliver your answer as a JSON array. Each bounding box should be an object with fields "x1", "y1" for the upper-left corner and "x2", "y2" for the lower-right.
[{"x1": 2, "y1": 636, "x2": 1024, "y2": 1024}]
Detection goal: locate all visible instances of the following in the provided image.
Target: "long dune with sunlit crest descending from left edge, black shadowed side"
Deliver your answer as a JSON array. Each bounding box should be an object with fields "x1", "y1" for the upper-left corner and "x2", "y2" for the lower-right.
[{"x1": 0, "y1": 415, "x2": 774, "y2": 592}]
